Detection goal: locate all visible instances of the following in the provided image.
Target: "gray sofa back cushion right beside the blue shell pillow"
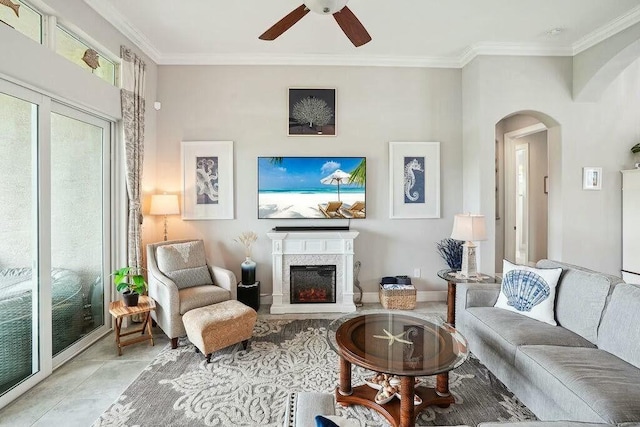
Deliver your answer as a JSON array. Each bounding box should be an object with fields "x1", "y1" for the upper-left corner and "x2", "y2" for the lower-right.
[{"x1": 537, "y1": 260, "x2": 622, "y2": 344}]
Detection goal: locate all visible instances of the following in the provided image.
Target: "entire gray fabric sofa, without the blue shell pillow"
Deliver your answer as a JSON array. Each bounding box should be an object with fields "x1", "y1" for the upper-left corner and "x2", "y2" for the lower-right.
[{"x1": 456, "y1": 260, "x2": 640, "y2": 425}]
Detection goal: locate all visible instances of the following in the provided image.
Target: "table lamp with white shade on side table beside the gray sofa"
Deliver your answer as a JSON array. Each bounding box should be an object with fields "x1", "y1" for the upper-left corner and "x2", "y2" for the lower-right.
[{"x1": 451, "y1": 214, "x2": 487, "y2": 278}]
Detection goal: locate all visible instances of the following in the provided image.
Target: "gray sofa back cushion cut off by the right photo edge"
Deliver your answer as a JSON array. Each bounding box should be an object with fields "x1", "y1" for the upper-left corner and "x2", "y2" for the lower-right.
[{"x1": 598, "y1": 283, "x2": 640, "y2": 368}]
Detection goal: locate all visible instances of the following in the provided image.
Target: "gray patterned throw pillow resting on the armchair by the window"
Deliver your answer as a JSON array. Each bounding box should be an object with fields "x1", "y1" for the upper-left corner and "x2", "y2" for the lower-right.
[{"x1": 156, "y1": 240, "x2": 213, "y2": 289}]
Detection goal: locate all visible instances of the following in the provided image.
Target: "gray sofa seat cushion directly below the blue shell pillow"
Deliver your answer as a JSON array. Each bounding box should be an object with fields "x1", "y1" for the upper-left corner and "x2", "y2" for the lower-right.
[{"x1": 465, "y1": 307, "x2": 595, "y2": 364}]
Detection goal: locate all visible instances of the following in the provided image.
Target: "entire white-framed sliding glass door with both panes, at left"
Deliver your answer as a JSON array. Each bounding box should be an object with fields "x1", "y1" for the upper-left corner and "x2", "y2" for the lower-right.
[{"x1": 0, "y1": 79, "x2": 113, "y2": 408}]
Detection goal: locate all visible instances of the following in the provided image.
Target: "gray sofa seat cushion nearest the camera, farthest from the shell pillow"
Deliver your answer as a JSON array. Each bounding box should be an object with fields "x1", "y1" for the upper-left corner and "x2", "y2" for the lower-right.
[{"x1": 515, "y1": 345, "x2": 640, "y2": 424}]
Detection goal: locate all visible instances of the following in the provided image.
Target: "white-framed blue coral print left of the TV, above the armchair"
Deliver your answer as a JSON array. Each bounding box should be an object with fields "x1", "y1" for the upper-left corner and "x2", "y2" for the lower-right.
[{"x1": 181, "y1": 141, "x2": 234, "y2": 220}]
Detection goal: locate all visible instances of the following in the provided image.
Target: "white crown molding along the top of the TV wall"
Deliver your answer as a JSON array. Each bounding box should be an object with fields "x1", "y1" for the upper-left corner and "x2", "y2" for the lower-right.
[{"x1": 158, "y1": 53, "x2": 459, "y2": 68}]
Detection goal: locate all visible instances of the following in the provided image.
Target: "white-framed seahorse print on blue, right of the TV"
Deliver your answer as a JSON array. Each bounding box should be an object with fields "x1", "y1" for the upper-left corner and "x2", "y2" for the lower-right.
[{"x1": 389, "y1": 142, "x2": 440, "y2": 219}]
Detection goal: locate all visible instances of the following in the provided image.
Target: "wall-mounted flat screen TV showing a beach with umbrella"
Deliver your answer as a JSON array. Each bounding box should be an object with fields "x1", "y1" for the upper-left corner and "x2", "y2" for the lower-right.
[{"x1": 258, "y1": 157, "x2": 367, "y2": 219}]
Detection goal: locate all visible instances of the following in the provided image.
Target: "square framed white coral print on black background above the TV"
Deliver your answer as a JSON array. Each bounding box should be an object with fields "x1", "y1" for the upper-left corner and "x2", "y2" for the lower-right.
[{"x1": 288, "y1": 88, "x2": 336, "y2": 136}]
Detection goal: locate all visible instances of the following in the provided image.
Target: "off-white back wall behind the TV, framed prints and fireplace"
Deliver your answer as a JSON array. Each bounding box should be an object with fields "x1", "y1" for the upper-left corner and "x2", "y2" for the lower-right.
[{"x1": 154, "y1": 66, "x2": 462, "y2": 297}]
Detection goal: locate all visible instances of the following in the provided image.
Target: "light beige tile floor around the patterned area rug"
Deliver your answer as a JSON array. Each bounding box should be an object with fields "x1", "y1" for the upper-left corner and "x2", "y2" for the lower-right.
[{"x1": 0, "y1": 302, "x2": 446, "y2": 427}]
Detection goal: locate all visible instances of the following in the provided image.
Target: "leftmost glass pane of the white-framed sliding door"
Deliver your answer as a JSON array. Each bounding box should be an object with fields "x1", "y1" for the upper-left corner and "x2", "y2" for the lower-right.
[{"x1": 0, "y1": 88, "x2": 40, "y2": 394}]
